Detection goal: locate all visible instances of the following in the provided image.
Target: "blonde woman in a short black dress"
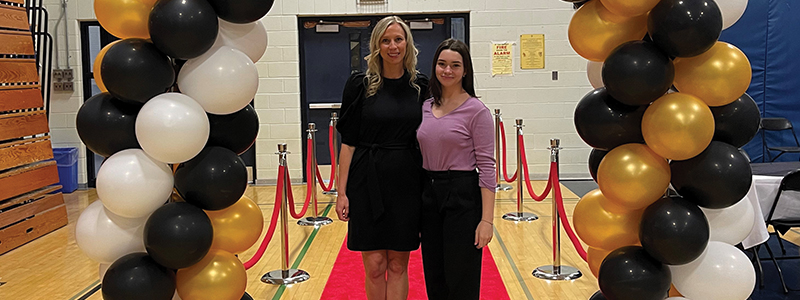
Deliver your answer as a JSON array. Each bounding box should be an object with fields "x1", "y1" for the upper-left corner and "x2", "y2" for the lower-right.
[{"x1": 336, "y1": 16, "x2": 428, "y2": 300}]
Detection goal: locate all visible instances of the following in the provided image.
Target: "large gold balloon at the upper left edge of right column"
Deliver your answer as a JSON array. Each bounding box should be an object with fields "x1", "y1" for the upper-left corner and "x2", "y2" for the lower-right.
[{"x1": 568, "y1": 0, "x2": 648, "y2": 61}]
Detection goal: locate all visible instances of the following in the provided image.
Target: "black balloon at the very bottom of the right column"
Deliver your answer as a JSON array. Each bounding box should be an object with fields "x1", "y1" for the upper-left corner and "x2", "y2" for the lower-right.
[{"x1": 597, "y1": 246, "x2": 672, "y2": 300}]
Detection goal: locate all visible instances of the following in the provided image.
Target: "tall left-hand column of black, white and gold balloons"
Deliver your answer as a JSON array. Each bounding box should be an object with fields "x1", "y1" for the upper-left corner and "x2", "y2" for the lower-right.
[{"x1": 75, "y1": 0, "x2": 274, "y2": 300}]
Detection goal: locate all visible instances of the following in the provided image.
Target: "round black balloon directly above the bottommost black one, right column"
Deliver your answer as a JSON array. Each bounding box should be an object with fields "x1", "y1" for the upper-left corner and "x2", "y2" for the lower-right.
[{"x1": 639, "y1": 197, "x2": 709, "y2": 265}]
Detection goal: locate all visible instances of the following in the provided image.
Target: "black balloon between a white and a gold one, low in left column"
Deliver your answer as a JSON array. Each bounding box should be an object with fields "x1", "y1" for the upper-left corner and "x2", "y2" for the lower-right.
[{"x1": 144, "y1": 202, "x2": 214, "y2": 269}]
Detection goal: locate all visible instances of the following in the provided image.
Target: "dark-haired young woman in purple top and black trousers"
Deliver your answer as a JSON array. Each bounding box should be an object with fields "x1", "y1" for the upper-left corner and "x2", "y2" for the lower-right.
[{"x1": 417, "y1": 39, "x2": 496, "y2": 300}]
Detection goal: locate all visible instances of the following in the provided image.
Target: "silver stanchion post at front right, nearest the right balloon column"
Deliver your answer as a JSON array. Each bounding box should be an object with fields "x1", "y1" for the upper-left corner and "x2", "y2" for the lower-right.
[{"x1": 533, "y1": 139, "x2": 583, "y2": 280}]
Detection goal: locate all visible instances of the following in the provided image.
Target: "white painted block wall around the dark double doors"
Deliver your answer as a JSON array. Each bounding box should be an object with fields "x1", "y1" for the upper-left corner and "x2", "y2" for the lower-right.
[{"x1": 46, "y1": 0, "x2": 591, "y2": 183}]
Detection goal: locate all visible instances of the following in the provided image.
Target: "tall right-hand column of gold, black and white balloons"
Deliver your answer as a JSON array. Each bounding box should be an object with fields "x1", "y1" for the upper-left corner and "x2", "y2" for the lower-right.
[{"x1": 569, "y1": 0, "x2": 760, "y2": 300}]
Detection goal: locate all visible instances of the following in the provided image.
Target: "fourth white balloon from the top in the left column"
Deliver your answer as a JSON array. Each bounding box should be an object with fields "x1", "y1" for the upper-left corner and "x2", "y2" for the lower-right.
[{"x1": 97, "y1": 149, "x2": 175, "y2": 218}]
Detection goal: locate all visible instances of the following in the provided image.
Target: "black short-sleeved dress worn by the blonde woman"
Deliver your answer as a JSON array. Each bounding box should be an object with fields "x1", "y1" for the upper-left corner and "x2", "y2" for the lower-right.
[{"x1": 337, "y1": 73, "x2": 428, "y2": 251}]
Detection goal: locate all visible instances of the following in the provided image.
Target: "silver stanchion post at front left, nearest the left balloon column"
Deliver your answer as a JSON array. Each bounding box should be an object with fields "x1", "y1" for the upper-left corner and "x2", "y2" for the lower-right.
[{"x1": 261, "y1": 144, "x2": 311, "y2": 285}]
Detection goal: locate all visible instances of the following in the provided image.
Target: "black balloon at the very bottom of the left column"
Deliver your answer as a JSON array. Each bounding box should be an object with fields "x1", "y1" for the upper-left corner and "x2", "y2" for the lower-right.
[{"x1": 101, "y1": 253, "x2": 175, "y2": 300}]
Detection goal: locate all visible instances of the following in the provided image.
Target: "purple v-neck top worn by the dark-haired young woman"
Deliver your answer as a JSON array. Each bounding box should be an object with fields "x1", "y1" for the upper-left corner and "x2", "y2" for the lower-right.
[{"x1": 417, "y1": 97, "x2": 497, "y2": 192}]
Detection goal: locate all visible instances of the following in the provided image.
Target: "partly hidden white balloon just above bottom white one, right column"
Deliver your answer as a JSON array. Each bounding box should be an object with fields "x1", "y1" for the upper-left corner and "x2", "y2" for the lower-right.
[{"x1": 700, "y1": 199, "x2": 755, "y2": 245}]
